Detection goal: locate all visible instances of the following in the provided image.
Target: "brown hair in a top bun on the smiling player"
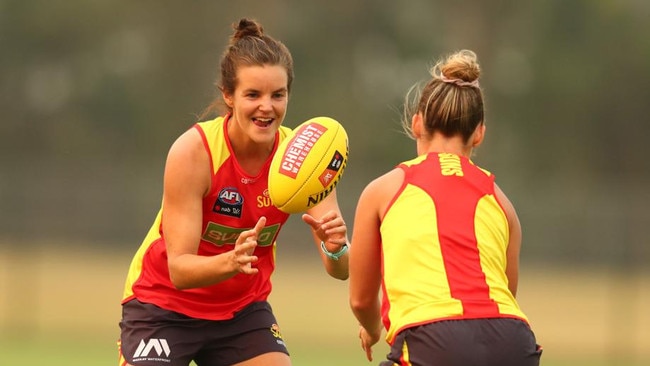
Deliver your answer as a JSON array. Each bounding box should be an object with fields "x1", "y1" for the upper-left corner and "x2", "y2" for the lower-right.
[{"x1": 200, "y1": 18, "x2": 293, "y2": 119}]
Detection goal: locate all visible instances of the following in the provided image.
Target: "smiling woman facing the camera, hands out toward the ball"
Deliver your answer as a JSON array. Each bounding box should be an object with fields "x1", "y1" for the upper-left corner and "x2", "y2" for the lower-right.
[{"x1": 119, "y1": 19, "x2": 348, "y2": 366}]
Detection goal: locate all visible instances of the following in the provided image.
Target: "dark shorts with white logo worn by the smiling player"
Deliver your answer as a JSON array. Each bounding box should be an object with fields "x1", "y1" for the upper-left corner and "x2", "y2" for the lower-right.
[{"x1": 118, "y1": 300, "x2": 289, "y2": 366}]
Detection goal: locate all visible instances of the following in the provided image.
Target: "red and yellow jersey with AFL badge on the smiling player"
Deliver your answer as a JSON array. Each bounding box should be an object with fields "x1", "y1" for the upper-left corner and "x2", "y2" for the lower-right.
[{"x1": 122, "y1": 117, "x2": 291, "y2": 320}]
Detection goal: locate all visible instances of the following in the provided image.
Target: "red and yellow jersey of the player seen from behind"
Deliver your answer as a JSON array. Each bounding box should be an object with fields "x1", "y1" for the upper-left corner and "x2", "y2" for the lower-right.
[{"x1": 380, "y1": 153, "x2": 527, "y2": 344}]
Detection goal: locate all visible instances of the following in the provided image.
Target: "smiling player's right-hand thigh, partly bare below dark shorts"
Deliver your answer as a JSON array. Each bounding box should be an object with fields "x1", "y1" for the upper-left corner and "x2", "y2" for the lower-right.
[{"x1": 195, "y1": 302, "x2": 291, "y2": 366}]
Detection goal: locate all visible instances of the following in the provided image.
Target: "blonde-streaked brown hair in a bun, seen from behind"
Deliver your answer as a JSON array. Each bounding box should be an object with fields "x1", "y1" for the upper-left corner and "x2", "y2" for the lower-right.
[{"x1": 402, "y1": 50, "x2": 485, "y2": 143}]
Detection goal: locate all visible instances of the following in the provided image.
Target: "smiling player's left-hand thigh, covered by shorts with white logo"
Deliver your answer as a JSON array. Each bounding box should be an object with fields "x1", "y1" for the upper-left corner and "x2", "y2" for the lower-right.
[{"x1": 118, "y1": 300, "x2": 205, "y2": 366}]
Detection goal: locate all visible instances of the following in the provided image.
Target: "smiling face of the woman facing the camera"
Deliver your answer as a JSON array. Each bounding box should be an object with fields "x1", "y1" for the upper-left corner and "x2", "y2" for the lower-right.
[{"x1": 223, "y1": 65, "x2": 289, "y2": 147}]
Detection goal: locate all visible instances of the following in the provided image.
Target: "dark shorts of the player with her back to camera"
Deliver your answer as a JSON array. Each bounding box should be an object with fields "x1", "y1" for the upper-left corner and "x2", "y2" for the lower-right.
[{"x1": 380, "y1": 318, "x2": 542, "y2": 366}]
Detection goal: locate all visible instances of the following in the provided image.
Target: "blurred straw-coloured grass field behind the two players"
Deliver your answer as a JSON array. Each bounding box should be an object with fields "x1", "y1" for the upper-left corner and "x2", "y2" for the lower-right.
[{"x1": 0, "y1": 246, "x2": 650, "y2": 366}]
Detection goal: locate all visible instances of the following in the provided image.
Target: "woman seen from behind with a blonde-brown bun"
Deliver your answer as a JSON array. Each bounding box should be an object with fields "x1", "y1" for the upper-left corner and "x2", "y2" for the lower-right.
[{"x1": 350, "y1": 50, "x2": 541, "y2": 366}]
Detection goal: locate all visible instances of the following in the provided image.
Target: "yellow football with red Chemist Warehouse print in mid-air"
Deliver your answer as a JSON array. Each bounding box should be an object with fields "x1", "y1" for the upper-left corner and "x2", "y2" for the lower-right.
[{"x1": 269, "y1": 117, "x2": 349, "y2": 213}]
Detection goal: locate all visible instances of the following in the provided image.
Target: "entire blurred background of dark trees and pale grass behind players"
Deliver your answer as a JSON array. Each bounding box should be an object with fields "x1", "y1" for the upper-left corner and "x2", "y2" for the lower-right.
[{"x1": 0, "y1": 0, "x2": 650, "y2": 365}]
